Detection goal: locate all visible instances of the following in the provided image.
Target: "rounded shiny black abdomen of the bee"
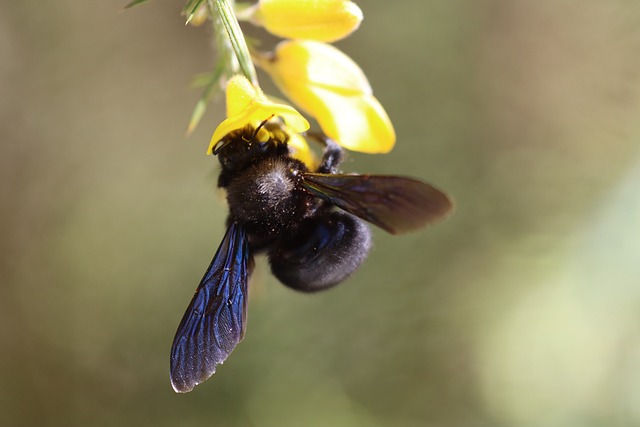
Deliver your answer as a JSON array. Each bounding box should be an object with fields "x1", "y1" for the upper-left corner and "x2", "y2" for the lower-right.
[{"x1": 269, "y1": 211, "x2": 371, "y2": 292}]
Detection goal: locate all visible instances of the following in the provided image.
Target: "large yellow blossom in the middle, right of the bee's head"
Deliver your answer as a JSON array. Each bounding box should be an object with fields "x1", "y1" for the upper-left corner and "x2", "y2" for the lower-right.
[{"x1": 256, "y1": 40, "x2": 396, "y2": 153}]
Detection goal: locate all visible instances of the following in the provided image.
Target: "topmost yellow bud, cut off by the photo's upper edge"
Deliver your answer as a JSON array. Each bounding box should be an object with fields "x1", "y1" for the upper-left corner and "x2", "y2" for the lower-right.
[{"x1": 251, "y1": 0, "x2": 362, "y2": 42}]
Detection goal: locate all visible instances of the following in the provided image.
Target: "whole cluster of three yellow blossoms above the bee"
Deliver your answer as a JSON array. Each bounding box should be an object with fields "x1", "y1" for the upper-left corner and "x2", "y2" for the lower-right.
[{"x1": 207, "y1": 0, "x2": 395, "y2": 161}]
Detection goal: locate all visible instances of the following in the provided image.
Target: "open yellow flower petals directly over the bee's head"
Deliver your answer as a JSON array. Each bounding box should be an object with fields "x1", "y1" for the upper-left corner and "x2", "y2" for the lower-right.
[{"x1": 207, "y1": 75, "x2": 309, "y2": 154}]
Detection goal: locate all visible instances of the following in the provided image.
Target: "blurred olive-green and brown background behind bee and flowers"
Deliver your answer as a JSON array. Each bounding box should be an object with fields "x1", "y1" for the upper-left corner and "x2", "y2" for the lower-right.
[{"x1": 0, "y1": 0, "x2": 640, "y2": 427}]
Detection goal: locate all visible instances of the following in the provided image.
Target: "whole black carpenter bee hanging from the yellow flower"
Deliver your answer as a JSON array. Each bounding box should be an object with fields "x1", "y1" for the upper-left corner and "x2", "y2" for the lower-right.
[{"x1": 171, "y1": 119, "x2": 452, "y2": 393}]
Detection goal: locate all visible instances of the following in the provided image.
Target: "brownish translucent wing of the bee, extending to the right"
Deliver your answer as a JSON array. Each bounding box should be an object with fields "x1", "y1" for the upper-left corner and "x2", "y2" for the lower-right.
[{"x1": 302, "y1": 173, "x2": 453, "y2": 234}]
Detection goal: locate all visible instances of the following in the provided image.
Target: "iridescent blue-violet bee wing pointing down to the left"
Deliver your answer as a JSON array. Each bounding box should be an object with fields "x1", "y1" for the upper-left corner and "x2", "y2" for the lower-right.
[{"x1": 171, "y1": 223, "x2": 253, "y2": 393}]
